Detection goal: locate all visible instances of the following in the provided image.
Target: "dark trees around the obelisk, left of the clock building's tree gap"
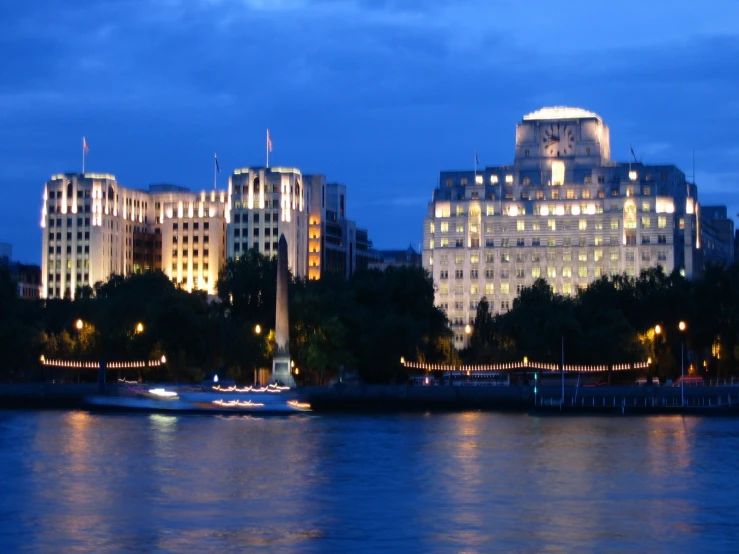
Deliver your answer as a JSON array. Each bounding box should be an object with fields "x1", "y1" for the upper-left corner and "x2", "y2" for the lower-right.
[{"x1": 0, "y1": 250, "x2": 455, "y2": 383}]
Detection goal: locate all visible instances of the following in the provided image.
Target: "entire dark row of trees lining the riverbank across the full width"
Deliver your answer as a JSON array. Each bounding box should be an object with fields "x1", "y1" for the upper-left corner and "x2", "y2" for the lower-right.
[{"x1": 0, "y1": 251, "x2": 739, "y2": 383}]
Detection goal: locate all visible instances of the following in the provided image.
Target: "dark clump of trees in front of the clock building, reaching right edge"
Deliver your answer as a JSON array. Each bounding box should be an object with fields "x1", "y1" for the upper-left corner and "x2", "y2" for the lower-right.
[{"x1": 463, "y1": 265, "x2": 739, "y2": 377}]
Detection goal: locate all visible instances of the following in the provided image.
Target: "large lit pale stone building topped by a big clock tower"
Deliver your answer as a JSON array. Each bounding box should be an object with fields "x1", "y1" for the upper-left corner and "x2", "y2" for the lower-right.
[{"x1": 423, "y1": 108, "x2": 702, "y2": 346}]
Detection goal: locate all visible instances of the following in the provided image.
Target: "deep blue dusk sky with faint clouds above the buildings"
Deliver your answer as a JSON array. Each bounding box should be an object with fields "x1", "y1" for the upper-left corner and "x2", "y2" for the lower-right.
[{"x1": 0, "y1": 0, "x2": 739, "y2": 263}]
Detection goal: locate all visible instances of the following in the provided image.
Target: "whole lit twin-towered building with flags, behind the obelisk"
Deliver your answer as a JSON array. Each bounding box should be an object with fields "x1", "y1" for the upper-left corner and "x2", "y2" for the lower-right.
[{"x1": 41, "y1": 167, "x2": 371, "y2": 298}]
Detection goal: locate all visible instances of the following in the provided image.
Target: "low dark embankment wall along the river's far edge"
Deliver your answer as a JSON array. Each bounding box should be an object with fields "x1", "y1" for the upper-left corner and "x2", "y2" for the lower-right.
[{"x1": 0, "y1": 383, "x2": 739, "y2": 415}]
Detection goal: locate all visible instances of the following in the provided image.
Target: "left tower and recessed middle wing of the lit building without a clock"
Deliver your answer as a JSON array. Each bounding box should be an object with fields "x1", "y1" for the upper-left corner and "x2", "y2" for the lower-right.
[{"x1": 41, "y1": 173, "x2": 226, "y2": 298}]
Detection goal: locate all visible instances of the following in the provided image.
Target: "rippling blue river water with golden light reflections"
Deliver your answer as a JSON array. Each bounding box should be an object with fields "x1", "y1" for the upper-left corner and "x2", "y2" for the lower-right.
[{"x1": 0, "y1": 412, "x2": 739, "y2": 553}]
